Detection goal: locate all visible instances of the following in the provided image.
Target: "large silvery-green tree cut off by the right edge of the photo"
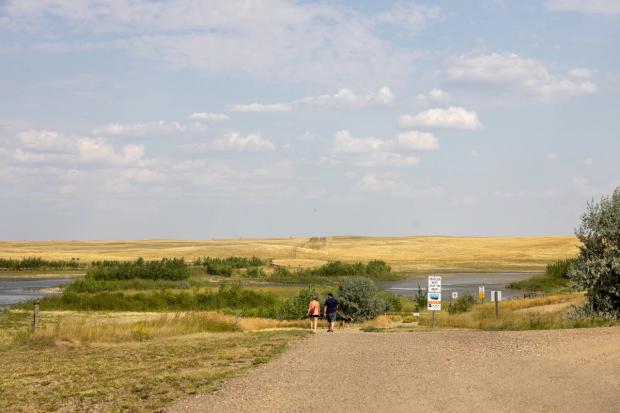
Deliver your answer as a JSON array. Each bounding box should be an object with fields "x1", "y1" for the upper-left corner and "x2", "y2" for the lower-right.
[{"x1": 569, "y1": 187, "x2": 620, "y2": 318}]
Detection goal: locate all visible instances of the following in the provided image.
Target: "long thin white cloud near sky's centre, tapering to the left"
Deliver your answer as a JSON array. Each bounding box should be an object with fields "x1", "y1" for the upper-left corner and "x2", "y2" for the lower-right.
[{"x1": 232, "y1": 86, "x2": 394, "y2": 112}]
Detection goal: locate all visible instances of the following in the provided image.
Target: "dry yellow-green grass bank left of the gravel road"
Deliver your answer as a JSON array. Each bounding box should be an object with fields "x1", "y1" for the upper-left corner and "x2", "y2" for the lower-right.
[{"x1": 0, "y1": 311, "x2": 305, "y2": 412}]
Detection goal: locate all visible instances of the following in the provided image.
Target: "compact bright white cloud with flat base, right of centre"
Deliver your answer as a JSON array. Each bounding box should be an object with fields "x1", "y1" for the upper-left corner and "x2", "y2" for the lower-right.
[{"x1": 398, "y1": 106, "x2": 482, "y2": 129}]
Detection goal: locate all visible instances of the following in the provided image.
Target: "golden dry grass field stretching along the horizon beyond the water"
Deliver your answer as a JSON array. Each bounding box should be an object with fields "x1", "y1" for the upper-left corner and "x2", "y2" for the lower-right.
[{"x1": 0, "y1": 236, "x2": 578, "y2": 271}]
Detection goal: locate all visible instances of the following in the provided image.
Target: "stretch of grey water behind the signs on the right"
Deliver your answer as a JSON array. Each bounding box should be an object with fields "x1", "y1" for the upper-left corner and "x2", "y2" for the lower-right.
[{"x1": 377, "y1": 273, "x2": 534, "y2": 301}]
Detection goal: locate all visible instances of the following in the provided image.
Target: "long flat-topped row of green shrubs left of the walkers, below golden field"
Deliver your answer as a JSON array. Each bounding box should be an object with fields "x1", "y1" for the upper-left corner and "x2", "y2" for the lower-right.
[{"x1": 86, "y1": 258, "x2": 191, "y2": 280}]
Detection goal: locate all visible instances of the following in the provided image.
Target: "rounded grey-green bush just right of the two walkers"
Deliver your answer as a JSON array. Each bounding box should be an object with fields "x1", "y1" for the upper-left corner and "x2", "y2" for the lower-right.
[{"x1": 338, "y1": 277, "x2": 385, "y2": 321}]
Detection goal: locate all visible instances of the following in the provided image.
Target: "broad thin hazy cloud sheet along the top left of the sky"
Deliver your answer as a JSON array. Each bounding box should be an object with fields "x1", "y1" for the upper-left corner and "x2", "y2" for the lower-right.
[{"x1": 4, "y1": 0, "x2": 422, "y2": 86}]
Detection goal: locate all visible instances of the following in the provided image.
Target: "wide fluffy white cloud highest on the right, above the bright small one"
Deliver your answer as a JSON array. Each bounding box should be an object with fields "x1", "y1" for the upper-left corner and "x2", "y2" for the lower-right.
[{"x1": 445, "y1": 53, "x2": 598, "y2": 100}]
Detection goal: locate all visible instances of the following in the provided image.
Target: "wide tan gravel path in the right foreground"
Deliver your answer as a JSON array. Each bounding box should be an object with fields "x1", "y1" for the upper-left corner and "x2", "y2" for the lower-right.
[{"x1": 168, "y1": 328, "x2": 620, "y2": 413}]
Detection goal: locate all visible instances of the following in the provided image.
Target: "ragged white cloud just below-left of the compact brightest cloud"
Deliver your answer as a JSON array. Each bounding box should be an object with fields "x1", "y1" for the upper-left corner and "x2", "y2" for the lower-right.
[{"x1": 322, "y1": 130, "x2": 439, "y2": 167}]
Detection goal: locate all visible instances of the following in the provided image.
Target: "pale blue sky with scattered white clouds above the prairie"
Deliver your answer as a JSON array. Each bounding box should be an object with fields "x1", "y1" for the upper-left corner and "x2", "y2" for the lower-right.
[{"x1": 0, "y1": 0, "x2": 620, "y2": 239}]
